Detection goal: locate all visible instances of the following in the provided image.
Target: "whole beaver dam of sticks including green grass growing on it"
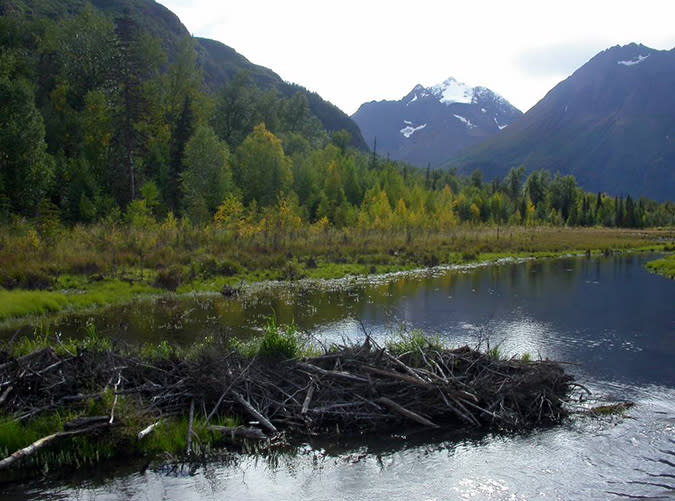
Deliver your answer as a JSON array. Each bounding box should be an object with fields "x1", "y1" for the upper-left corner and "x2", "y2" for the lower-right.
[{"x1": 0, "y1": 329, "x2": 575, "y2": 470}]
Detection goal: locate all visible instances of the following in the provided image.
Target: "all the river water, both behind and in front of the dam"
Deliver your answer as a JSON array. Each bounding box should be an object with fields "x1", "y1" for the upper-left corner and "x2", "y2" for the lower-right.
[{"x1": 0, "y1": 256, "x2": 675, "y2": 499}]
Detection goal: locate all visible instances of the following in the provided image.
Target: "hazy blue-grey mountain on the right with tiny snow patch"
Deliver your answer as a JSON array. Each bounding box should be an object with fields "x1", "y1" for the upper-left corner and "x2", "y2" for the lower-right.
[{"x1": 448, "y1": 43, "x2": 675, "y2": 201}]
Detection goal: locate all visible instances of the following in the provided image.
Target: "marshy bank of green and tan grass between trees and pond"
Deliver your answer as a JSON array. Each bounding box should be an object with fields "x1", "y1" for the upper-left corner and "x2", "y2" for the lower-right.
[{"x1": 0, "y1": 226, "x2": 675, "y2": 321}]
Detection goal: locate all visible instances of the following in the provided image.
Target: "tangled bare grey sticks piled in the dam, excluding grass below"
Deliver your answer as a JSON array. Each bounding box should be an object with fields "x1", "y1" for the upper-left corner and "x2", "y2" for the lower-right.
[{"x1": 0, "y1": 339, "x2": 573, "y2": 438}]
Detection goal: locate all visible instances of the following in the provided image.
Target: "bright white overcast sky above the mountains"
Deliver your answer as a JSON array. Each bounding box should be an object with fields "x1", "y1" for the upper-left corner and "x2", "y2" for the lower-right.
[{"x1": 158, "y1": 0, "x2": 675, "y2": 115}]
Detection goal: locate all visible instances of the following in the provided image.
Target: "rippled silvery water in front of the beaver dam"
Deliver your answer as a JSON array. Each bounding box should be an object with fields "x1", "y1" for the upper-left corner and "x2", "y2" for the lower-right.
[{"x1": 6, "y1": 383, "x2": 675, "y2": 500}]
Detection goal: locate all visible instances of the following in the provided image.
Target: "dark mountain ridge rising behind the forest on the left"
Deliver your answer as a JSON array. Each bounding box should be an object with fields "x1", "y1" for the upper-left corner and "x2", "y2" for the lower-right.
[{"x1": 6, "y1": 0, "x2": 368, "y2": 150}]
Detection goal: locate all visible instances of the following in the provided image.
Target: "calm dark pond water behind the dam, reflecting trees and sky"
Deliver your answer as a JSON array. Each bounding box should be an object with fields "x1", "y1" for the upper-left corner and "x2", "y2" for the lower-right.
[{"x1": 2, "y1": 255, "x2": 675, "y2": 385}]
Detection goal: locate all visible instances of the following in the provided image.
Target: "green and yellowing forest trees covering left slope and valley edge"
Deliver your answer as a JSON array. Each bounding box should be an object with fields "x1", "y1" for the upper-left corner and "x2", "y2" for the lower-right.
[{"x1": 0, "y1": 6, "x2": 675, "y2": 233}]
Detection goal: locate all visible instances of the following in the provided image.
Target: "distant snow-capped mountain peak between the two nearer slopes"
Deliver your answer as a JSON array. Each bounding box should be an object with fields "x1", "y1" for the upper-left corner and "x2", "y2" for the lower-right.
[{"x1": 352, "y1": 78, "x2": 522, "y2": 167}]
